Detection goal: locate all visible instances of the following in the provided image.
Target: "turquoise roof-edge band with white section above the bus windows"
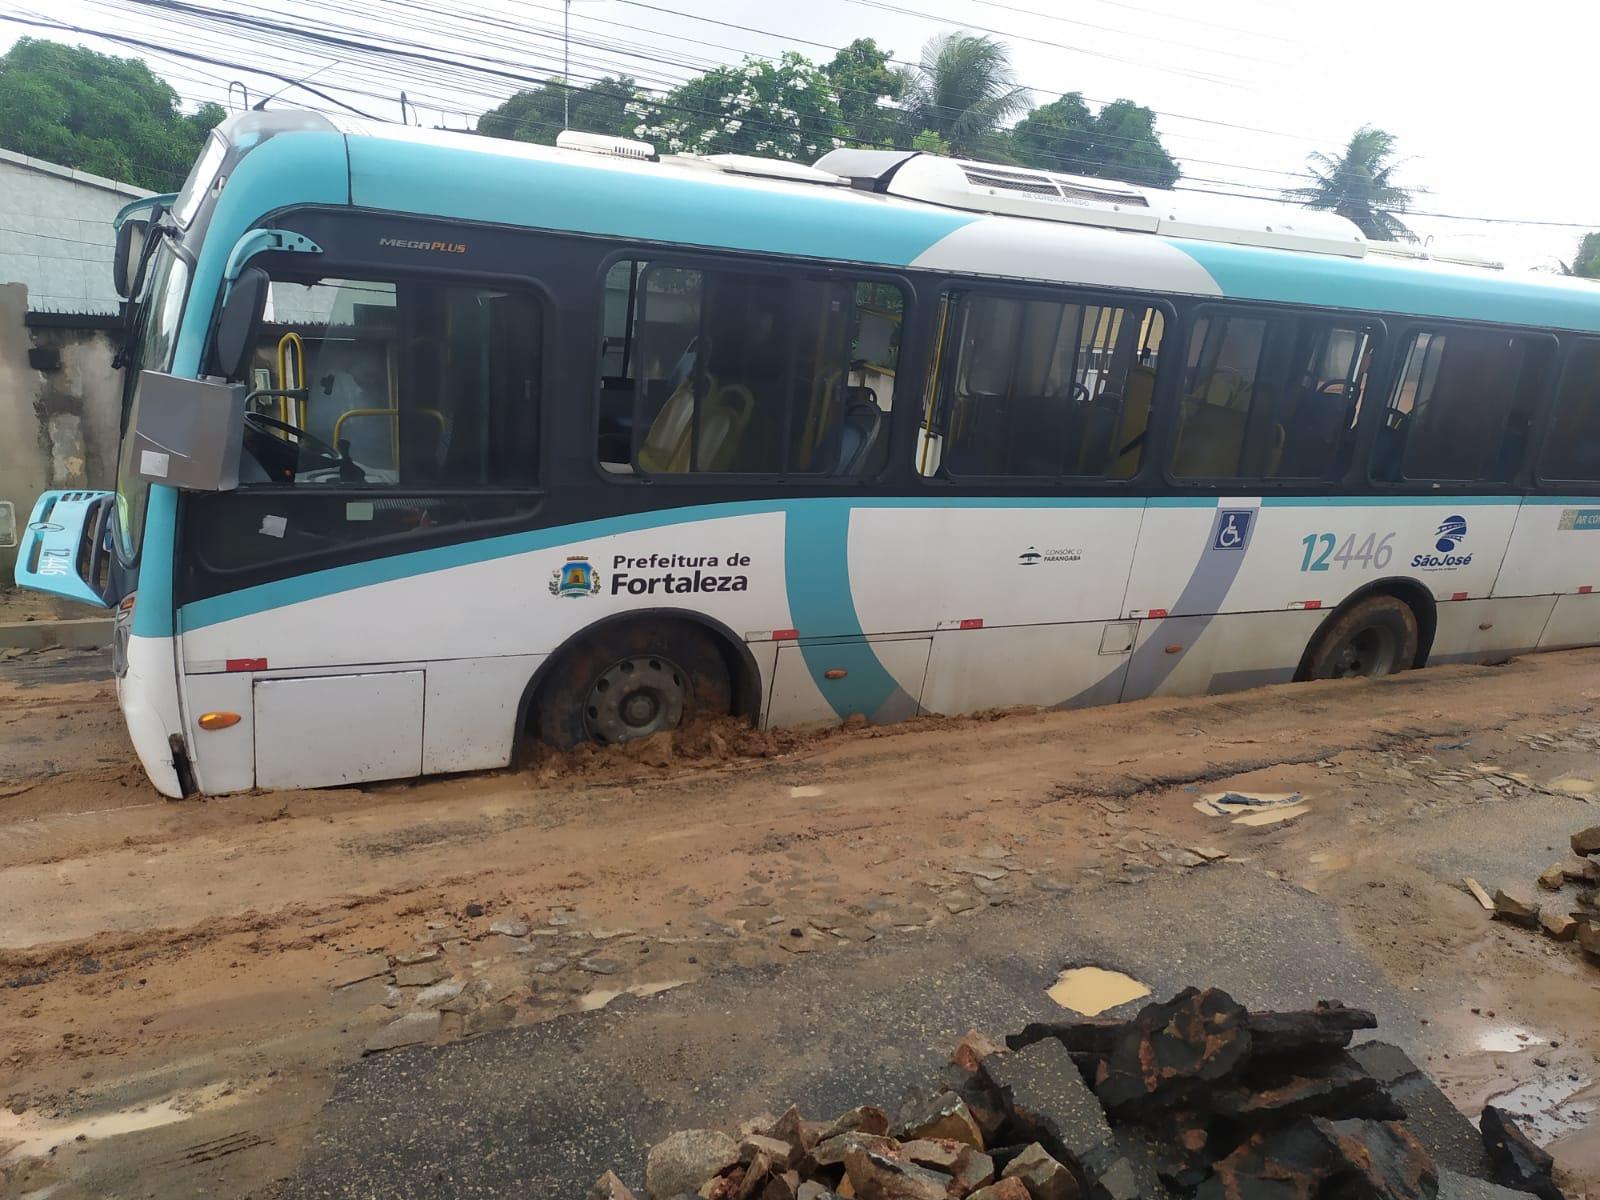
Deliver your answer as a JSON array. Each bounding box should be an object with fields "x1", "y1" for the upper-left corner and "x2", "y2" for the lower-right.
[{"x1": 209, "y1": 110, "x2": 1600, "y2": 331}]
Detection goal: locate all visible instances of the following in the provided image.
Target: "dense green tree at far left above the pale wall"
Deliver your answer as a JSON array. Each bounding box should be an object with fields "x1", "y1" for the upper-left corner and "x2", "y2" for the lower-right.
[{"x1": 0, "y1": 37, "x2": 227, "y2": 192}]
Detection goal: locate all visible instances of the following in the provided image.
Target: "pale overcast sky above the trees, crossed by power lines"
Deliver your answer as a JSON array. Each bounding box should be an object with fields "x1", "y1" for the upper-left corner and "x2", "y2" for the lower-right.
[{"x1": 0, "y1": 0, "x2": 1600, "y2": 267}]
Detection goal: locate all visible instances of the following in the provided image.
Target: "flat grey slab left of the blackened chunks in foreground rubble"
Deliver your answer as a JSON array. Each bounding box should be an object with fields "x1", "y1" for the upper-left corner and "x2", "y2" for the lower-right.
[{"x1": 981, "y1": 1038, "x2": 1110, "y2": 1165}]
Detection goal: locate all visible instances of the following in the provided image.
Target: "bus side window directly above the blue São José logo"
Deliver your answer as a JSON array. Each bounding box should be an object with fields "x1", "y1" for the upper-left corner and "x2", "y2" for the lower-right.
[{"x1": 1371, "y1": 326, "x2": 1550, "y2": 483}]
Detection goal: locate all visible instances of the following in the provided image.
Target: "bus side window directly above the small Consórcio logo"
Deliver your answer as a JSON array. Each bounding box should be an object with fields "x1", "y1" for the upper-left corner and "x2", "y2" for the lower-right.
[{"x1": 917, "y1": 291, "x2": 1165, "y2": 478}]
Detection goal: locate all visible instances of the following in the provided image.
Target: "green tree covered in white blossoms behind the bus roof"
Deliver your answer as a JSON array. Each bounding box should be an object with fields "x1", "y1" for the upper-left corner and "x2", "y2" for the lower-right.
[{"x1": 634, "y1": 51, "x2": 842, "y2": 163}]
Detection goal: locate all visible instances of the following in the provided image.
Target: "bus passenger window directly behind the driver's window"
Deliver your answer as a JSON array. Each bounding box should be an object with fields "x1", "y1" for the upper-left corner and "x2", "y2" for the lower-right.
[{"x1": 597, "y1": 262, "x2": 904, "y2": 477}]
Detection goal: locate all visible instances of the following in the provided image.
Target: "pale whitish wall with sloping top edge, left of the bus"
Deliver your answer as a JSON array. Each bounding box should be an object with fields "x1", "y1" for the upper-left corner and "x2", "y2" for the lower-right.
[{"x1": 0, "y1": 150, "x2": 150, "y2": 320}]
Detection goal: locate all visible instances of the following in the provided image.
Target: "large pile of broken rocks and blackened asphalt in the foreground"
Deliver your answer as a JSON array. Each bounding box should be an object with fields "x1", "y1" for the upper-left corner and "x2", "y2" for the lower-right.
[{"x1": 589, "y1": 989, "x2": 1560, "y2": 1200}]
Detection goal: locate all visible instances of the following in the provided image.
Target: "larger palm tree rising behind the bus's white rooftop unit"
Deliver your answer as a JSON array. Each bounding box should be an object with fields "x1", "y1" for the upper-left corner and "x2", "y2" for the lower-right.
[{"x1": 906, "y1": 30, "x2": 1029, "y2": 158}]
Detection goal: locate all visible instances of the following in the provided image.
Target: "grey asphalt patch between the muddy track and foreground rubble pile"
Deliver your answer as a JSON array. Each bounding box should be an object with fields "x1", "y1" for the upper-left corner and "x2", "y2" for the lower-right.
[{"x1": 285, "y1": 864, "x2": 1421, "y2": 1200}]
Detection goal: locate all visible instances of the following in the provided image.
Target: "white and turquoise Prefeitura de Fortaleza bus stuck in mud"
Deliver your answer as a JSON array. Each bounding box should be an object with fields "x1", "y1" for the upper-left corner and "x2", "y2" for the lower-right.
[{"x1": 16, "y1": 110, "x2": 1600, "y2": 797}]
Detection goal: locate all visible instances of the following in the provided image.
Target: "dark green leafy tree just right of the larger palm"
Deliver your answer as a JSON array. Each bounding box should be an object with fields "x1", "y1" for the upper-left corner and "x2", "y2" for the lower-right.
[{"x1": 1011, "y1": 91, "x2": 1181, "y2": 187}]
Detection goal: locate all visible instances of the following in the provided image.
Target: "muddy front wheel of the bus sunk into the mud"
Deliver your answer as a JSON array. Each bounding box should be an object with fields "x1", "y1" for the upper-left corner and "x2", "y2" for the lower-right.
[{"x1": 534, "y1": 622, "x2": 733, "y2": 750}]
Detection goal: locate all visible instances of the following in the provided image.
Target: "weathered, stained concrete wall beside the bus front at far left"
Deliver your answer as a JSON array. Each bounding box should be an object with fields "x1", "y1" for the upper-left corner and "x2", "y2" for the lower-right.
[{"x1": 0, "y1": 283, "x2": 122, "y2": 582}]
